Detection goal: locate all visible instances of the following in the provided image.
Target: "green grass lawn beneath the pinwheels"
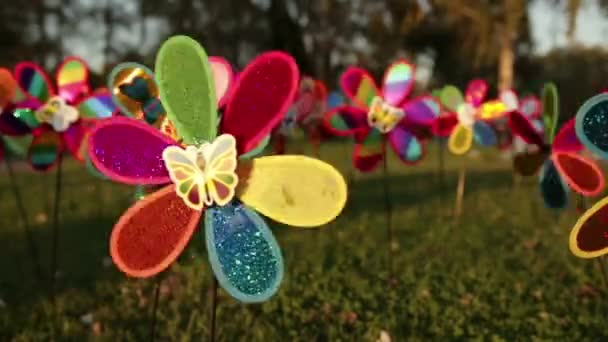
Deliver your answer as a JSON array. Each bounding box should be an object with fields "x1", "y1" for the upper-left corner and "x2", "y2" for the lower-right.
[{"x1": 0, "y1": 138, "x2": 608, "y2": 341}]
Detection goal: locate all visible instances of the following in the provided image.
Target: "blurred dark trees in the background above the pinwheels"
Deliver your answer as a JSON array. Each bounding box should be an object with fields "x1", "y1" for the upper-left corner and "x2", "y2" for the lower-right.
[{"x1": 0, "y1": 0, "x2": 608, "y2": 115}]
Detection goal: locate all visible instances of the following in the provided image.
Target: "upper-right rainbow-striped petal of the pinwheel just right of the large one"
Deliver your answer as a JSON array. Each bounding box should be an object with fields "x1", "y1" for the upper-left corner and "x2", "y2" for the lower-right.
[{"x1": 382, "y1": 59, "x2": 416, "y2": 107}]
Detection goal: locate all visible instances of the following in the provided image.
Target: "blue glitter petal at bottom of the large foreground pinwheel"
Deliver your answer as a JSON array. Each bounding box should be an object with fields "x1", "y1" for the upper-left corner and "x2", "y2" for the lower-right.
[{"x1": 205, "y1": 201, "x2": 283, "y2": 303}]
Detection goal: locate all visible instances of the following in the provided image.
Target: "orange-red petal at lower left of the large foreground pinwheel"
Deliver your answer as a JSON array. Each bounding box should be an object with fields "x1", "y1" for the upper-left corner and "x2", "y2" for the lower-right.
[{"x1": 110, "y1": 185, "x2": 202, "y2": 278}]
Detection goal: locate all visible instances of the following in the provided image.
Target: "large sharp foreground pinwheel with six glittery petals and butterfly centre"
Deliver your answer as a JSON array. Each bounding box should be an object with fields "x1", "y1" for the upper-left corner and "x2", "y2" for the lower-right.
[{"x1": 89, "y1": 36, "x2": 346, "y2": 302}]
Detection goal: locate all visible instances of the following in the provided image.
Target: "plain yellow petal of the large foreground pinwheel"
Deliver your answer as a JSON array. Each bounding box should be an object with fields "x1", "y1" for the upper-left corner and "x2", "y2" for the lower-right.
[{"x1": 236, "y1": 156, "x2": 347, "y2": 227}]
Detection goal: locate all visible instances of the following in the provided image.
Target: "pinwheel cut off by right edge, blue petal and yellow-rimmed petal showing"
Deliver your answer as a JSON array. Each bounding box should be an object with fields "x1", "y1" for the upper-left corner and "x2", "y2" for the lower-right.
[{"x1": 570, "y1": 93, "x2": 608, "y2": 258}]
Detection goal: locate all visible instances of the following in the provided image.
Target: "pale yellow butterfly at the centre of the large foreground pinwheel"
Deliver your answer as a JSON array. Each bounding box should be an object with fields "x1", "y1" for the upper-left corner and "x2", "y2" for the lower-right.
[{"x1": 163, "y1": 134, "x2": 238, "y2": 210}]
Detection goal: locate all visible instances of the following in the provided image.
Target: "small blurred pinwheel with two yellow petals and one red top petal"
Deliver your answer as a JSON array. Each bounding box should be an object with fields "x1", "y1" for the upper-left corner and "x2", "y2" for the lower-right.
[{"x1": 433, "y1": 80, "x2": 507, "y2": 155}]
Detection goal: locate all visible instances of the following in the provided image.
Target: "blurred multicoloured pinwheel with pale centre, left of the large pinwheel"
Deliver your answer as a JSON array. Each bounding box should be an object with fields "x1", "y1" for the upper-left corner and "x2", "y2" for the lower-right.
[{"x1": 0, "y1": 57, "x2": 116, "y2": 170}]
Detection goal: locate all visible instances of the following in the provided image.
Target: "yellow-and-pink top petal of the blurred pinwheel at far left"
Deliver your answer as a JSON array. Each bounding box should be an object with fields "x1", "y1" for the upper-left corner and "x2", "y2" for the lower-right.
[{"x1": 56, "y1": 56, "x2": 91, "y2": 104}]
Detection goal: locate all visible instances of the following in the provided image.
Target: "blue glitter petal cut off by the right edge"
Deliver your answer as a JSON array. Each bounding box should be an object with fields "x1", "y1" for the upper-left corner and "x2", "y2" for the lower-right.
[{"x1": 575, "y1": 94, "x2": 608, "y2": 159}]
